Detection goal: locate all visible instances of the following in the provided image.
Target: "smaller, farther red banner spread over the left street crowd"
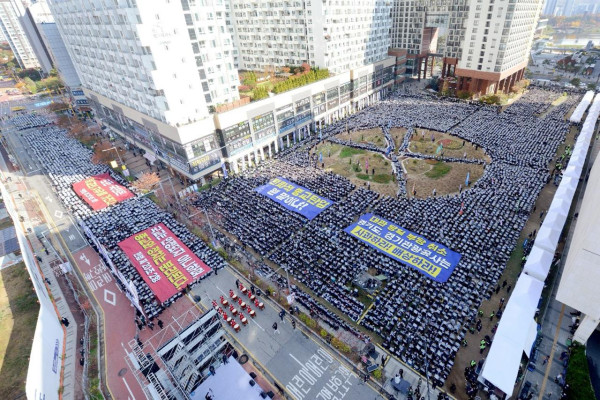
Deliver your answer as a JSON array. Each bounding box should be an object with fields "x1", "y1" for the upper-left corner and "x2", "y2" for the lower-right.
[{"x1": 73, "y1": 173, "x2": 134, "y2": 211}]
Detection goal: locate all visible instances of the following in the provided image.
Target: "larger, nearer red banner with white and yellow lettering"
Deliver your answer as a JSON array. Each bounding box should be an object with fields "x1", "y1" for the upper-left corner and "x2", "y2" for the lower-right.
[{"x1": 119, "y1": 222, "x2": 210, "y2": 303}]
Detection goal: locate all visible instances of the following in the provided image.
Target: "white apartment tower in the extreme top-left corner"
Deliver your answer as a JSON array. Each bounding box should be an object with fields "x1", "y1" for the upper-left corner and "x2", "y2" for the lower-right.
[{"x1": 0, "y1": 0, "x2": 40, "y2": 69}]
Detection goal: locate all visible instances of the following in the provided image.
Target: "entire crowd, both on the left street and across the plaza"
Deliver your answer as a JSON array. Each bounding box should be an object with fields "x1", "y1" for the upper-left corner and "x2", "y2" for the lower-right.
[{"x1": 13, "y1": 85, "x2": 578, "y2": 386}]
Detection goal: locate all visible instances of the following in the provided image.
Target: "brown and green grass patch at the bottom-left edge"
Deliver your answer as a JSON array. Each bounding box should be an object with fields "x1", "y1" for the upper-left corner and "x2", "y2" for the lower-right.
[{"x1": 0, "y1": 263, "x2": 40, "y2": 399}]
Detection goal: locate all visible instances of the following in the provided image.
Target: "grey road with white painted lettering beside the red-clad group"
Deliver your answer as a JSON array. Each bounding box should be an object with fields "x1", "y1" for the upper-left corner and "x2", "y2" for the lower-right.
[{"x1": 192, "y1": 268, "x2": 383, "y2": 400}]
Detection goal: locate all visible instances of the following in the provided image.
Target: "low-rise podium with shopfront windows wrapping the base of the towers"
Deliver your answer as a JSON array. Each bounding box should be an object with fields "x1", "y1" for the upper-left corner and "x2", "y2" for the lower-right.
[{"x1": 91, "y1": 57, "x2": 396, "y2": 183}]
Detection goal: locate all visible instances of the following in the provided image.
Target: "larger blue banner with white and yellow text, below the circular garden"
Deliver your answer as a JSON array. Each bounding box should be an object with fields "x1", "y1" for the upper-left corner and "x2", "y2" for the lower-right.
[{"x1": 344, "y1": 214, "x2": 461, "y2": 282}]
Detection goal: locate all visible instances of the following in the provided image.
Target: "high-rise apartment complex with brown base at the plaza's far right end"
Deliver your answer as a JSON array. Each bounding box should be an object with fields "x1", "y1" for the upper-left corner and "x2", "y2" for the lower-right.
[{"x1": 392, "y1": 0, "x2": 543, "y2": 93}]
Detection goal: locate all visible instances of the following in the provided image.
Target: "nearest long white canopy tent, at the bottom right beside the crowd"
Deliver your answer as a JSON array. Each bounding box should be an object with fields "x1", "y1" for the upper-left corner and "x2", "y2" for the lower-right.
[{"x1": 481, "y1": 274, "x2": 544, "y2": 396}]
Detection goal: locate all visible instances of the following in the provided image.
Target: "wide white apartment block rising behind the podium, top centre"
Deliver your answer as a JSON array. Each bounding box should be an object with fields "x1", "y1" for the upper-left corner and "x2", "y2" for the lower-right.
[{"x1": 230, "y1": 0, "x2": 392, "y2": 74}]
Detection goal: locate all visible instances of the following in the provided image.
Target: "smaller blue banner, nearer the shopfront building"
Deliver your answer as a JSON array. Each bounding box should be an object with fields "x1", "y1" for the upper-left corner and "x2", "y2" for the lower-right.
[{"x1": 254, "y1": 178, "x2": 333, "y2": 220}]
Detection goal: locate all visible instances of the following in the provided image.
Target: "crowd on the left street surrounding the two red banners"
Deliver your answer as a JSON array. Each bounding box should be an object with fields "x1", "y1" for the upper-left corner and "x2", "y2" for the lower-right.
[{"x1": 23, "y1": 126, "x2": 224, "y2": 323}]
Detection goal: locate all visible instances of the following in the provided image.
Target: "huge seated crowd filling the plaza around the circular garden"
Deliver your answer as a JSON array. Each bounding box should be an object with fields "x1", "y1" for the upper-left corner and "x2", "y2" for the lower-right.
[{"x1": 196, "y1": 89, "x2": 578, "y2": 386}]
